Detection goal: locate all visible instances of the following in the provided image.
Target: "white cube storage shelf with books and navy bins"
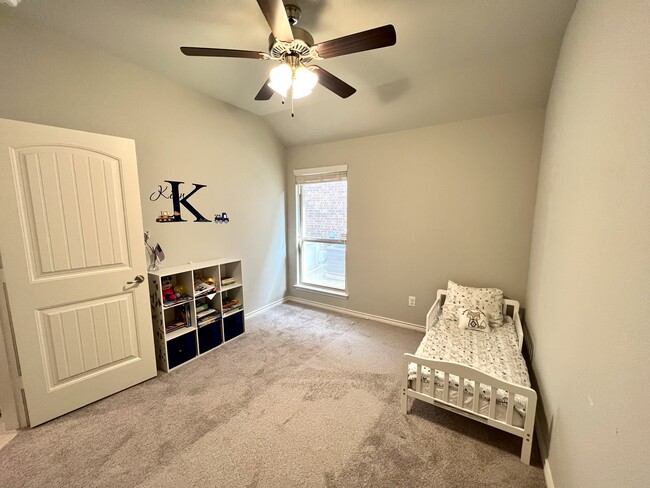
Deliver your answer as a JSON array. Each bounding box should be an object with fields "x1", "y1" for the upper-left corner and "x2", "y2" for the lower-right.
[{"x1": 149, "y1": 258, "x2": 245, "y2": 372}]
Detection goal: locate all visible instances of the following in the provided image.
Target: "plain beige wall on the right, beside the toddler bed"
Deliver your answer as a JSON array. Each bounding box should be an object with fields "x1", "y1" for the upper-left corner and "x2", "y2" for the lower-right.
[{"x1": 526, "y1": 0, "x2": 650, "y2": 487}]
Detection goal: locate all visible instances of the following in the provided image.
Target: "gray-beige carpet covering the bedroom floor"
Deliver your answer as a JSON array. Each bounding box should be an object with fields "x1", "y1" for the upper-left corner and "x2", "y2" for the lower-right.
[{"x1": 0, "y1": 304, "x2": 544, "y2": 488}]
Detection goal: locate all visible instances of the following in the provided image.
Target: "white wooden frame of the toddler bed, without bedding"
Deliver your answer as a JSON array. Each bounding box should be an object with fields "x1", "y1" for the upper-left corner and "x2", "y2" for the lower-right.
[{"x1": 400, "y1": 290, "x2": 537, "y2": 464}]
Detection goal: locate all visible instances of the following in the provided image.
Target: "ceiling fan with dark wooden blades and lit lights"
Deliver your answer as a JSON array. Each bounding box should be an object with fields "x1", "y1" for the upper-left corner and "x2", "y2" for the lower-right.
[{"x1": 181, "y1": 0, "x2": 397, "y2": 106}]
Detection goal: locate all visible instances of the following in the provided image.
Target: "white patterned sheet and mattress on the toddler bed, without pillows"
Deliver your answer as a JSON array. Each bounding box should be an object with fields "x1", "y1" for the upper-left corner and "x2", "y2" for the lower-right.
[{"x1": 408, "y1": 315, "x2": 530, "y2": 416}]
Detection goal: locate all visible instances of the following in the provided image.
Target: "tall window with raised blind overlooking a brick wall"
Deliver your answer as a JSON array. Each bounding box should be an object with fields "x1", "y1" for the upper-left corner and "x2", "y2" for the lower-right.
[{"x1": 294, "y1": 166, "x2": 348, "y2": 295}]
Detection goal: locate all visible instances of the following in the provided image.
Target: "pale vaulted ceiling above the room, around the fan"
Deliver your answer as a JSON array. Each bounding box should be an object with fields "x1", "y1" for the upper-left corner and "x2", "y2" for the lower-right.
[{"x1": 2, "y1": 0, "x2": 575, "y2": 146}]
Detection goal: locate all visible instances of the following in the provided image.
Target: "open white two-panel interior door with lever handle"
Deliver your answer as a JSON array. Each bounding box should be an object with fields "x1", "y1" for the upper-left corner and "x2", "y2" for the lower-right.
[{"x1": 0, "y1": 119, "x2": 156, "y2": 426}]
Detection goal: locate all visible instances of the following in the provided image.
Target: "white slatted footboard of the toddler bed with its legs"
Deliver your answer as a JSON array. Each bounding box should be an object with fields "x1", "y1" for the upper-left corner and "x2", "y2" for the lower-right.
[{"x1": 400, "y1": 354, "x2": 537, "y2": 464}]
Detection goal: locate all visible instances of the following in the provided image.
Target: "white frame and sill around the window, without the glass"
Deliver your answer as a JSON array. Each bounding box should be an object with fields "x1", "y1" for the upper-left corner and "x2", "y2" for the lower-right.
[{"x1": 293, "y1": 164, "x2": 348, "y2": 298}]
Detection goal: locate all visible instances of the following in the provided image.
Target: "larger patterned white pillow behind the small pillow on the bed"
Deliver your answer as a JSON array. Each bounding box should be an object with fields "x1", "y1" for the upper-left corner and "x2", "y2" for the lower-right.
[{"x1": 442, "y1": 280, "x2": 503, "y2": 327}]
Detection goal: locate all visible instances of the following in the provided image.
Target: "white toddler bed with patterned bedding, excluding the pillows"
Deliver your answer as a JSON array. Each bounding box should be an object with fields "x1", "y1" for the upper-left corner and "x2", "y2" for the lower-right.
[{"x1": 400, "y1": 282, "x2": 537, "y2": 464}]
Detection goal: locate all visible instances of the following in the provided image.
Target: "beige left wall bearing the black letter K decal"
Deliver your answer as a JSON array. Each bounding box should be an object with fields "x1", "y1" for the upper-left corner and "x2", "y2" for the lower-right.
[{"x1": 0, "y1": 18, "x2": 286, "y2": 311}]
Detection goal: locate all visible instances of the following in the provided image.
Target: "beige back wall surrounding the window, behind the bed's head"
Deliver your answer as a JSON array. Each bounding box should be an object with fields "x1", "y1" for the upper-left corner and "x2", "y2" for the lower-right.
[{"x1": 287, "y1": 110, "x2": 544, "y2": 324}]
